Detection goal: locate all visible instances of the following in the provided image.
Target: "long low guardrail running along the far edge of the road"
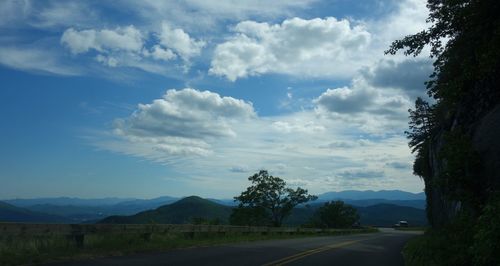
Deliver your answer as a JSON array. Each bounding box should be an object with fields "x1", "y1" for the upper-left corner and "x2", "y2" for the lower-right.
[{"x1": 0, "y1": 223, "x2": 368, "y2": 247}]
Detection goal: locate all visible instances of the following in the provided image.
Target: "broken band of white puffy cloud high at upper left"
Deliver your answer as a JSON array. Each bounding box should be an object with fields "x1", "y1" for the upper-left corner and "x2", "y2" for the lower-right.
[{"x1": 60, "y1": 22, "x2": 205, "y2": 74}]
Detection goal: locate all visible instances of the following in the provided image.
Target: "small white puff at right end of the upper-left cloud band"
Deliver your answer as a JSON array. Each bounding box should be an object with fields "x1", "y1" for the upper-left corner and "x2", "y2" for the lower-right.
[{"x1": 158, "y1": 22, "x2": 205, "y2": 60}]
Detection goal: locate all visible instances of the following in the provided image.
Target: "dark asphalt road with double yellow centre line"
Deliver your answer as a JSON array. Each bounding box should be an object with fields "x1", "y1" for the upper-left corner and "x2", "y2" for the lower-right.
[{"x1": 51, "y1": 229, "x2": 417, "y2": 266}]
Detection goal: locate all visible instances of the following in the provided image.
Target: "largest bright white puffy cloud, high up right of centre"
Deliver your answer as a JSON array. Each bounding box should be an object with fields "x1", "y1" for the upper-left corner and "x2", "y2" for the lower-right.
[{"x1": 210, "y1": 17, "x2": 371, "y2": 81}]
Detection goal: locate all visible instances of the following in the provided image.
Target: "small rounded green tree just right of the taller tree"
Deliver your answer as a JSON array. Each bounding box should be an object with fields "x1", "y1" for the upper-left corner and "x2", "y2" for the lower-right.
[{"x1": 315, "y1": 200, "x2": 359, "y2": 228}]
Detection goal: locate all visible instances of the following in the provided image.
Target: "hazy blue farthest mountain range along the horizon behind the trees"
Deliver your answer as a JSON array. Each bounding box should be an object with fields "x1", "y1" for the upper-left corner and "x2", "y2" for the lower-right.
[{"x1": 0, "y1": 190, "x2": 425, "y2": 224}]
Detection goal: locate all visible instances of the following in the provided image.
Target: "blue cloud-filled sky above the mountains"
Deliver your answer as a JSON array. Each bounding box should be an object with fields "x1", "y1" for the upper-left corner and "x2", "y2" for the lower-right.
[{"x1": 0, "y1": 0, "x2": 432, "y2": 199}]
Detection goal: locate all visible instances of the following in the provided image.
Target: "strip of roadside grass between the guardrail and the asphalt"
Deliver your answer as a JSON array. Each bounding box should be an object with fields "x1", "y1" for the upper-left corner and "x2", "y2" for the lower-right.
[{"x1": 0, "y1": 228, "x2": 378, "y2": 265}]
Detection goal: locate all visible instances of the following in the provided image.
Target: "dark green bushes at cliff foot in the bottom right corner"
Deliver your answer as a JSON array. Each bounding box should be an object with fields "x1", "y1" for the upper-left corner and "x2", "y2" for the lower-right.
[{"x1": 403, "y1": 193, "x2": 500, "y2": 266}]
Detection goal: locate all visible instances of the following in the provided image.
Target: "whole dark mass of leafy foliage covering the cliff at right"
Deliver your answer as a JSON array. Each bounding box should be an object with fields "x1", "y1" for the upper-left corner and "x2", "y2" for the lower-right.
[{"x1": 386, "y1": 0, "x2": 500, "y2": 265}]
